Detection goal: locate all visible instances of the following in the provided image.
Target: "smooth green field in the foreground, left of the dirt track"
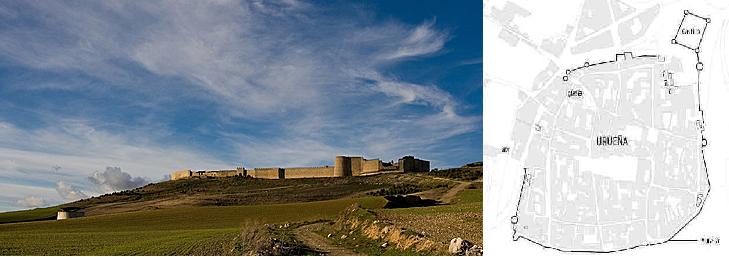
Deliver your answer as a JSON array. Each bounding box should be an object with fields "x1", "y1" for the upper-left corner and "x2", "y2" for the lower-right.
[{"x1": 0, "y1": 197, "x2": 386, "y2": 255}]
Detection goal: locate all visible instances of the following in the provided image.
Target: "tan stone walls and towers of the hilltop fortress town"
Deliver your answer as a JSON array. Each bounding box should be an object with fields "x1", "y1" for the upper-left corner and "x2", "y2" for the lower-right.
[{"x1": 170, "y1": 156, "x2": 430, "y2": 180}]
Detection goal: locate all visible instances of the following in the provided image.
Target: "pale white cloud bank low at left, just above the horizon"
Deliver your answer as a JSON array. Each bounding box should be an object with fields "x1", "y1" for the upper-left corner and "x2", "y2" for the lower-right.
[{"x1": 0, "y1": 120, "x2": 233, "y2": 209}]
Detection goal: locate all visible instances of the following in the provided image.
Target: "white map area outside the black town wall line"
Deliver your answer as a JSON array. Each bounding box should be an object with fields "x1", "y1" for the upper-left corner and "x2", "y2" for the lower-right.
[{"x1": 483, "y1": 0, "x2": 729, "y2": 256}]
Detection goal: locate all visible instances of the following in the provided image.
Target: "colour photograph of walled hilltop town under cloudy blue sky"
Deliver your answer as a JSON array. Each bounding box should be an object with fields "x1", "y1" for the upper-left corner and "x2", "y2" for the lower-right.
[{"x1": 0, "y1": 0, "x2": 484, "y2": 256}]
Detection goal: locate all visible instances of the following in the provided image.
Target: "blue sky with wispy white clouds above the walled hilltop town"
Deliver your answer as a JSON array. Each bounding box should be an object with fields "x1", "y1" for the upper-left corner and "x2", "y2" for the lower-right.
[{"x1": 0, "y1": 0, "x2": 482, "y2": 211}]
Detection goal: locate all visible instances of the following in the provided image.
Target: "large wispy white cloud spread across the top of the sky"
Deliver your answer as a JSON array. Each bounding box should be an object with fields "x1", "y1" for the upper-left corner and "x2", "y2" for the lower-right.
[{"x1": 0, "y1": 1, "x2": 456, "y2": 117}]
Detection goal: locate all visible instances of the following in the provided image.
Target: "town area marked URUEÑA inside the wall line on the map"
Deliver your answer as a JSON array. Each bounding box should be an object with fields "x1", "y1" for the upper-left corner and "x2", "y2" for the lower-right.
[{"x1": 511, "y1": 53, "x2": 709, "y2": 252}]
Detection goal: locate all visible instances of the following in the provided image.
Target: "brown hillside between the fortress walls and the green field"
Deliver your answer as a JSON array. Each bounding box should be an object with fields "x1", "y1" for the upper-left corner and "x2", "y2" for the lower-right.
[{"x1": 0, "y1": 168, "x2": 472, "y2": 224}]
